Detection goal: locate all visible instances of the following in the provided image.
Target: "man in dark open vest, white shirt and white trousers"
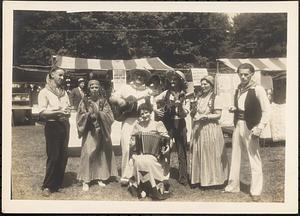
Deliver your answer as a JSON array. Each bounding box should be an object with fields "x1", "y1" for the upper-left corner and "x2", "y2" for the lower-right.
[{"x1": 225, "y1": 63, "x2": 270, "y2": 201}]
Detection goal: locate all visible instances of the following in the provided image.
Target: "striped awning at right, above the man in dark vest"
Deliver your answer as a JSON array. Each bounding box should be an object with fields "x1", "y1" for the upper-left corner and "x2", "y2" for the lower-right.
[{"x1": 217, "y1": 58, "x2": 286, "y2": 79}]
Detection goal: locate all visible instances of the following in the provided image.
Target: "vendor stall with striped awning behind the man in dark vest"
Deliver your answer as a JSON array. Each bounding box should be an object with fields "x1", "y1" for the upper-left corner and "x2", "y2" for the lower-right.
[{"x1": 216, "y1": 58, "x2": 286, "y2": 141}]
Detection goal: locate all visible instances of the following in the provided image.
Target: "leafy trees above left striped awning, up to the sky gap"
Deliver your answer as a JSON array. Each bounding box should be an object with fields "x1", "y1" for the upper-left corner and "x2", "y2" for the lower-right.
[{"x1": 14, "y1": 11, "x2": 230, "y2": 67}]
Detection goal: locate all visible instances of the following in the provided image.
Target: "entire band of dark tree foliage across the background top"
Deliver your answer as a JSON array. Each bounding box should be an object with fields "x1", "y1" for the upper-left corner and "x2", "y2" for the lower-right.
[{"x1": 14, "y1": 11, "x2": 286, "y2": 68}]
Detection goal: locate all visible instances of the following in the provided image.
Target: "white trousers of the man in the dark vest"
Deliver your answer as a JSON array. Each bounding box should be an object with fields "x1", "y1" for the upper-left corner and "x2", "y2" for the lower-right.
[{"x1": 225, "y1": 120, "x2": 263, "y2": 196}]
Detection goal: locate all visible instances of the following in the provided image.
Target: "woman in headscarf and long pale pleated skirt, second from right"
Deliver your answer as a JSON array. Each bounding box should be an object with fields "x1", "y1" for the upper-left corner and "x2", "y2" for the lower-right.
[{"x1": 191, "y1": 76, "x2": 228, "y2": 186}]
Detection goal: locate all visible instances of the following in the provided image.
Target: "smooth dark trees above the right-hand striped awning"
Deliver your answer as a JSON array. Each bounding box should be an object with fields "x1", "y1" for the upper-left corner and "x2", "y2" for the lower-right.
[{"x1": 231, "y1": 13, "x2": 287, "y2": 58}]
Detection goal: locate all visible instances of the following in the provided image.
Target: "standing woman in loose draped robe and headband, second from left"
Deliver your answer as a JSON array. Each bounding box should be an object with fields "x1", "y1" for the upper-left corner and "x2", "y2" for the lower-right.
[{"x1": 77, "y1": 80, "x2": 118, "y2": 191}]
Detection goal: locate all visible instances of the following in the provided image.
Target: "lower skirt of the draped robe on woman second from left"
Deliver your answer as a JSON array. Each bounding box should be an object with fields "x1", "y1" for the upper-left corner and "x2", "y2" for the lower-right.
[{"x1": 77, "y1": 132, "x2": 118, "y2": 182}]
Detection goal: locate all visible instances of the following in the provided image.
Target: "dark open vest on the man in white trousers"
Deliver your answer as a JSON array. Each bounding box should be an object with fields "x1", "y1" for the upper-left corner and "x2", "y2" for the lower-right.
[{"x1": 233, "y1": 89, "x2": 262, "y2": 130}]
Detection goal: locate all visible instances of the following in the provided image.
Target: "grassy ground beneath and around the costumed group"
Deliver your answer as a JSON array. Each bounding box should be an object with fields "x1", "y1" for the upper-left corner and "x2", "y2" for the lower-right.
[{"x1": 12, "y1": 126, "x2": 285, "y2": 202}]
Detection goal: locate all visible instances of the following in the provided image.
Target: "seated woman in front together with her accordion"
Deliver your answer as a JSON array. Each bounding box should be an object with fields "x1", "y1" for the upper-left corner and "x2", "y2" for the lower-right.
[{"x1": 126, "y1": 103, "x2": 172, "y2": 200}]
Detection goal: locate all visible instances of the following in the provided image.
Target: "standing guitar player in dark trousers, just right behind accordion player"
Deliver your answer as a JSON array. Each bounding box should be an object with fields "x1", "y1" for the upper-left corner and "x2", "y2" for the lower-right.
[{"x1": 154, "y1": 71, "x2": 189, "y2": 185}]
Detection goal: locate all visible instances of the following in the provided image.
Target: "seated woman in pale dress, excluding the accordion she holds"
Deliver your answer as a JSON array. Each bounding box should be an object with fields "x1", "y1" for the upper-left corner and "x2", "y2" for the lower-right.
[{"x1": 127, "y1": 103, "x2": 172, "y2": 200}]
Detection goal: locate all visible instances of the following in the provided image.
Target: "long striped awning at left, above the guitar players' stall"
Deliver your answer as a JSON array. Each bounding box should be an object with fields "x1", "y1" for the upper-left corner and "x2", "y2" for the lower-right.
[{"x1": 55, "y1": 56, "x2": 172, "y2": 70}]
